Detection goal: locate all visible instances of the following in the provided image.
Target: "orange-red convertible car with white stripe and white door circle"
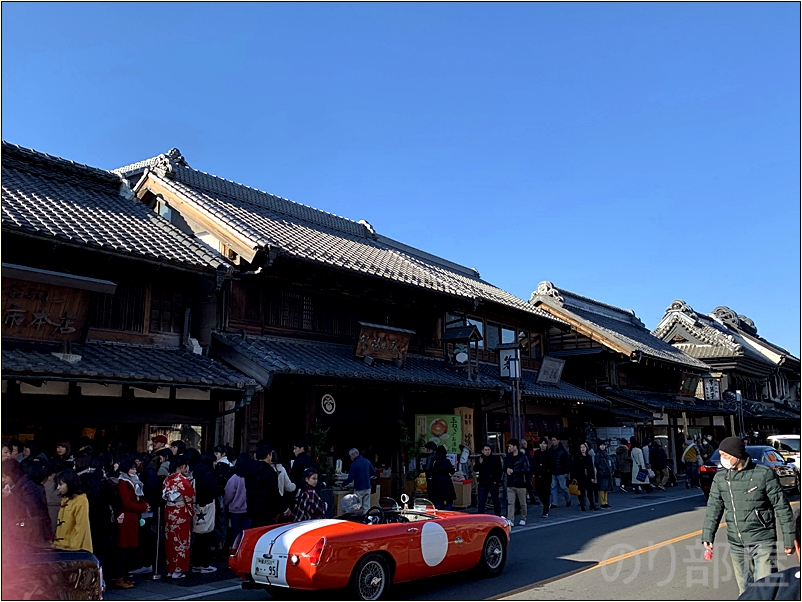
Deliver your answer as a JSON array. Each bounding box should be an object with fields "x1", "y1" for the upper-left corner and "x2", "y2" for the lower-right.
[{"x1": 228, "y1": 495, "x2": 510, "y2": 600}]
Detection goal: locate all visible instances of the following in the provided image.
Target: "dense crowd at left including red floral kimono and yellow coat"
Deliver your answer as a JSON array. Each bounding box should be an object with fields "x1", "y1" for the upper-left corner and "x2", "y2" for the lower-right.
[{"x1": 1, "y1": 434, "x2": 334, "y2": 589}]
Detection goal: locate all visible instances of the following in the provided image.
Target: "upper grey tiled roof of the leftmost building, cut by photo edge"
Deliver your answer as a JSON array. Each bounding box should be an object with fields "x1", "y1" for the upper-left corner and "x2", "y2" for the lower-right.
[{"x1": 2, "y1": 142, "x2": 231, "y2": 270}]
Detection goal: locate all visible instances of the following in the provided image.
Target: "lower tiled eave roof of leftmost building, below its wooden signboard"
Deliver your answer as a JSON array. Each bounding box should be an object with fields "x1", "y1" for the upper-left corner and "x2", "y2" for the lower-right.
[{"x1": 2, "y1": 339, "x2": 251, "y2": 389}]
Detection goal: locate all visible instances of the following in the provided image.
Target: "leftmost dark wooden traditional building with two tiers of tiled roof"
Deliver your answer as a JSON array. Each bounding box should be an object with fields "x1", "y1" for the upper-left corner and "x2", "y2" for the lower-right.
[{"x1": 2, "y1": 142, "x2": 261, "y2": 454}]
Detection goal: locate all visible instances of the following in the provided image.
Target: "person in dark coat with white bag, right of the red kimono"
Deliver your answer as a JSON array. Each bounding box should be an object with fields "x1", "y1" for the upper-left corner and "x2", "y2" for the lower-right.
[{"x1": 191, "y1": 452, "x2": 221, "y2": 574}]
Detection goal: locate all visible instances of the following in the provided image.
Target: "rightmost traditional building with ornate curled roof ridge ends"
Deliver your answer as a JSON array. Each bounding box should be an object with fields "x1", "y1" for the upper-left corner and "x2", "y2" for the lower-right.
[{"x1": 653, "y1": 299, "x2": 800, "y2": 436}]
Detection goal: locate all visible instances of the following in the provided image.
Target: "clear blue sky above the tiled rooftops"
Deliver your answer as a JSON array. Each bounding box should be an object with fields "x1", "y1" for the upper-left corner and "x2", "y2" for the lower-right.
[{"x1": 2, "y1": 2, "x2": 800, "y2": 356}]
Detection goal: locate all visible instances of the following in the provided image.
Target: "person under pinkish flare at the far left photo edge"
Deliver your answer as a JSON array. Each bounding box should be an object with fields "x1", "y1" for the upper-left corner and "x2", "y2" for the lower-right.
[{"x1": 2, "y1": 458, "x2": 54, "y2": 550}]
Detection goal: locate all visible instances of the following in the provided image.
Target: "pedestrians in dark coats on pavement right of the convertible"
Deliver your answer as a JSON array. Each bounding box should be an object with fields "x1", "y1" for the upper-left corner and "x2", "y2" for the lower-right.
[{"x1": 472, "y1": 436, "x2": 718, "y2": 526}]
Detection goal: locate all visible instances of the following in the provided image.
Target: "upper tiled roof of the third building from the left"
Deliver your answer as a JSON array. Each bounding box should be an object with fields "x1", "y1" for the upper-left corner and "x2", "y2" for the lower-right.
[{"x1": 529, "y1": 282, "x2": 707, "y2": 370}]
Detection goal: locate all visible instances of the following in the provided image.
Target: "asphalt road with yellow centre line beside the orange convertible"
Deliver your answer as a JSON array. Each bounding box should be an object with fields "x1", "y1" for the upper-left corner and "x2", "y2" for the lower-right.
[{"x1": 186, "y1": 494, "x2": 799, "y2": 600}]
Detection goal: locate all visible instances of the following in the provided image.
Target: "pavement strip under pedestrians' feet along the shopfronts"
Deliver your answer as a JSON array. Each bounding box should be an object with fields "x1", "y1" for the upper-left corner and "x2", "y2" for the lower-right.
[{"x1": 106, "y1": 484, "x2": 705, "y2": 601}]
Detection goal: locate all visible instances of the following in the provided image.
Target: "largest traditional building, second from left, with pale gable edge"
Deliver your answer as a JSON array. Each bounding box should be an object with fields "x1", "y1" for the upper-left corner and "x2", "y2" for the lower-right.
[{"x1": 109, "y1": 149, "x2": 606, "y2": 465}]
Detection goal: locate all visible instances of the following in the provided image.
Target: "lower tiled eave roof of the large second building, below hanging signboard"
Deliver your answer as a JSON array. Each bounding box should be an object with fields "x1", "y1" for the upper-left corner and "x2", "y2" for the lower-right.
[{"x1": 214, "y1": 333, "x2": 501, "y2": 389}]
